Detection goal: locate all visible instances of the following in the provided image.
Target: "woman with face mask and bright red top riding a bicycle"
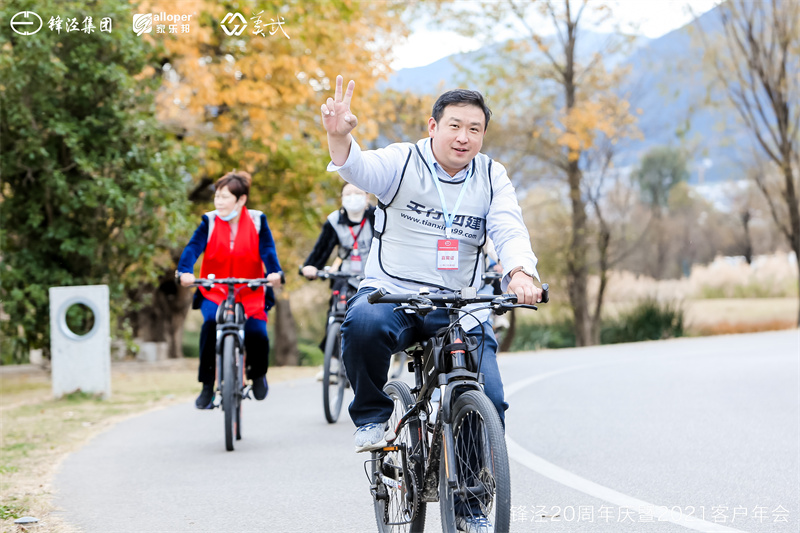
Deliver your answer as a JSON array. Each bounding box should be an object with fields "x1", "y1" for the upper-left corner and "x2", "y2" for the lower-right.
[{"x1": 176, "y1": 171, "x2": 282, "y2": 409}]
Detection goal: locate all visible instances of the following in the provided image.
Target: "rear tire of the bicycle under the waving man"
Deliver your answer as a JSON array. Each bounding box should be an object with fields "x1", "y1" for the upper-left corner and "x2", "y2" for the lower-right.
[{"x1": 371, "y1": 381, "x2": 426, "y2": 533}]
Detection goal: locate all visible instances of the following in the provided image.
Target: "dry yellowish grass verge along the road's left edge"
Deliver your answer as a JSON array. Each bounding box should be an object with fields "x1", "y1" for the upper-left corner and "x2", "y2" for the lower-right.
[{"x1": 0, "y1": 359, "x2": 317, "y2": 533}]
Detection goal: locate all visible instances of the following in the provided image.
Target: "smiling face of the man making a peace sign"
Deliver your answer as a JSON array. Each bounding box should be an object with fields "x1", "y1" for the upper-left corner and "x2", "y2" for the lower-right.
[{"x1": 428, "y1": 104, "x2": 486, "y2": 176}]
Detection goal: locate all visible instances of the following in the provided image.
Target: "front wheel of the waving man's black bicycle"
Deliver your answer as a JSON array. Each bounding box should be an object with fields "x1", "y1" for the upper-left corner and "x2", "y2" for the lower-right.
[{"x1": 439, "y1": 390, "x2": 511, "y2": 531}]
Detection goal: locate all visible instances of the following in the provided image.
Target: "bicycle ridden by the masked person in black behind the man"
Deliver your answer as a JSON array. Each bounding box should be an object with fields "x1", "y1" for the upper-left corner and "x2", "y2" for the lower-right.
[{"x1": 306, "y1": 269, "x2": 364, "y2": 424}]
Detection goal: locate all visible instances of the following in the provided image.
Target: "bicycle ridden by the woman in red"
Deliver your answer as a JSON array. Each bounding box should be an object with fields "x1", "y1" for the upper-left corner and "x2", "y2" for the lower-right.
[{"x1": 192, "y1": 274, "x2": 272, "y2": 452}]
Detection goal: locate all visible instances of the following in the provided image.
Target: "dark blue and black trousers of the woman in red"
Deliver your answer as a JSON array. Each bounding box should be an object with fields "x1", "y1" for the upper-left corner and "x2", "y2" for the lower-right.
[{"x1": 197, "y1": 299, "x2": 269, "y2": 384}]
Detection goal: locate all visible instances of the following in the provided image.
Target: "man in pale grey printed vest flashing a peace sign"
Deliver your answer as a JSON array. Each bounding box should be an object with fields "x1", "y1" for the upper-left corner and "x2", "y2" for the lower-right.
[{"x1": 321, "y1": 76, "x2": 542, "y2": 512}]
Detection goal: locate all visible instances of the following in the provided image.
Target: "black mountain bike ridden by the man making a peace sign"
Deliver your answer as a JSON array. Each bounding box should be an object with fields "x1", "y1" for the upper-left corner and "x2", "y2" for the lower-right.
[{"x1": 367, "y1": 284, "x2": 549, "y2": 533}]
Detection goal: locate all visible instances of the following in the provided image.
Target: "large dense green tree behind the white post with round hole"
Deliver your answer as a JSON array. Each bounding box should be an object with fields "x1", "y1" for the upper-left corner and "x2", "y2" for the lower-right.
[{"x1": 0, "y1": 0, "x2": 195, "y2": 361}]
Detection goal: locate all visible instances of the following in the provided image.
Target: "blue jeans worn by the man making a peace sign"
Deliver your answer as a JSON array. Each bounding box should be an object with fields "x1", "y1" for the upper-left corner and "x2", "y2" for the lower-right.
[{"x1": 342, "y1": 288, "x2": 508, "y2": 426}]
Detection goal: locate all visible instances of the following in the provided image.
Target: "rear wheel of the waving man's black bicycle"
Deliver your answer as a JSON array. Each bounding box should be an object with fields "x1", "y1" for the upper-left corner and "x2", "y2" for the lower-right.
[{"x1": 371, "y1": 381, "x2": 425, "y2": 533}]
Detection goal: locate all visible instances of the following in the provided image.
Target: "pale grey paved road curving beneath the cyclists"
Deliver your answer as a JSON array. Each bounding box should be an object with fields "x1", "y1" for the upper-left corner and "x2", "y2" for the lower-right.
[{"x1": 55, "y1": 330, "x2": 800, "y2": 533}]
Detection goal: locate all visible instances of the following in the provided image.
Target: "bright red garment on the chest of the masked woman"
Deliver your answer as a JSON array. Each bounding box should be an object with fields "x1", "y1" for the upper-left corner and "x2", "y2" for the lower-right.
[{"x1": 200, "y1": 207, "x2": 267, "y2": 320}]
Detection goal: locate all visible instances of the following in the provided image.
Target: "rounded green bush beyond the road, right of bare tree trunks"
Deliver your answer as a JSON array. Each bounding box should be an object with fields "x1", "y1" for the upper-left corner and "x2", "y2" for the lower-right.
[{"x1": 600, "y1": 298, "x2": 684, "y2": 344}]
